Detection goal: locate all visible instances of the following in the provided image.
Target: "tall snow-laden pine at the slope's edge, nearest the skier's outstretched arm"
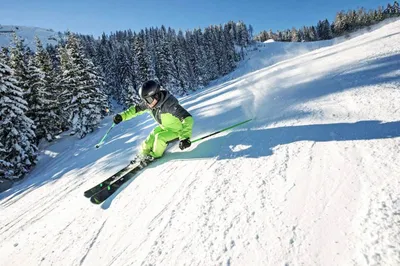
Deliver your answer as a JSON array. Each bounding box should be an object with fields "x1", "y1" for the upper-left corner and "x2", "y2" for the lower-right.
[{"x1": 61, "y1": 33, "x2": 107, "y2": 138}]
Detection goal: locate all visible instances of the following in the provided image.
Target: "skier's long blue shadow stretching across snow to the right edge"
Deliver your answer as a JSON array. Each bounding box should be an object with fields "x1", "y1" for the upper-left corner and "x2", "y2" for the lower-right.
[{"x1": 101, "y1": 120, "x2": 400, "y2": 209}]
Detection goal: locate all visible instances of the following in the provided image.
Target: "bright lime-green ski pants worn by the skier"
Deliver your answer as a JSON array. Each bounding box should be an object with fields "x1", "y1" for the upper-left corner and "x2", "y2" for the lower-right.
[{"x1": 142, "y1": 126, "x2": 179, "y2": 158}]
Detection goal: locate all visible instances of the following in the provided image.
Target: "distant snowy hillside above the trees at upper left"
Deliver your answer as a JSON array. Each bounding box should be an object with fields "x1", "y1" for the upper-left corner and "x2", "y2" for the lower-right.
[{"x1": 0, "y1": 25, "x2": 60, "y2": 50}]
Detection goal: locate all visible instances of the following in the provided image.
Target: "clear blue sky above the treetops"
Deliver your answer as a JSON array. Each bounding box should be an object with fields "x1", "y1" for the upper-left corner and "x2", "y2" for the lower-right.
[{"x1": 0, "y1": 0, "x2": 394, "y2": 36}]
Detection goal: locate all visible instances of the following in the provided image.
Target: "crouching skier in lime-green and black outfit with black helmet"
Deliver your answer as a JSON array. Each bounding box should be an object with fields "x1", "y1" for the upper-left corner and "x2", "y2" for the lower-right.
[{"x1": 114, "y1": 80, "x2": 194, "y2": 164}]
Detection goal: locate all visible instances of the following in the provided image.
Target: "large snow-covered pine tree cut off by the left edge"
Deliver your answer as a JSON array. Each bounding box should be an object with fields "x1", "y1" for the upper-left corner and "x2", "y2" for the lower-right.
[{"x1": 0, "y1": 59, "x2": 37, "y2": 179}]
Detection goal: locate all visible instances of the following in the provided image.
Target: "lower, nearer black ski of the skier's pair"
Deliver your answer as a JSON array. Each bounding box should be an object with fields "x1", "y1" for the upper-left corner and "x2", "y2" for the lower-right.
[{"x1": 90, "y1": 164, "x2": 151, "y2": 204}]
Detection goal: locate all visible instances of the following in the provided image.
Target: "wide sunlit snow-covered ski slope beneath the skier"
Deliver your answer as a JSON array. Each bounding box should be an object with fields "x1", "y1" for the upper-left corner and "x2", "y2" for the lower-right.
[{"x1": 0, "y1": 21, "x2": 400, "y2": 265}]
